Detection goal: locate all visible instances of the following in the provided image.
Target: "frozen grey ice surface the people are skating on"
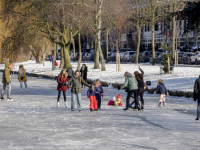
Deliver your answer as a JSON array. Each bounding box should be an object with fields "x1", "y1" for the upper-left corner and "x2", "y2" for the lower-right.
[{"x1": 0, "y1": 75, "x2": 200, "y2": 150}]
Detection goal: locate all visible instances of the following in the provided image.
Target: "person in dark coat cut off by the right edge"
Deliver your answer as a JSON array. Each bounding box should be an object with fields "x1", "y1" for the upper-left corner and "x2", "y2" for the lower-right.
[{"x1": 194, "y1": 76, "x2": 200, "y2": 120}]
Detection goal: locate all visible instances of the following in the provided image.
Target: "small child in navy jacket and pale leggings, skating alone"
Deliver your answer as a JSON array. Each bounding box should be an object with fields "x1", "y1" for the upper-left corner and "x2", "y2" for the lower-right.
[{"x1": 154, "y1": 79, "x2": 168, "y2": 107}]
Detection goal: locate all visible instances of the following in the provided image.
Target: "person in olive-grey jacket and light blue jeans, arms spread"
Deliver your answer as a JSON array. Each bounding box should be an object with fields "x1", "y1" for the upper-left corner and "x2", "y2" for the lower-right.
[{"x1": 66, "y1": 70, "x2": 90, "y2": 112}]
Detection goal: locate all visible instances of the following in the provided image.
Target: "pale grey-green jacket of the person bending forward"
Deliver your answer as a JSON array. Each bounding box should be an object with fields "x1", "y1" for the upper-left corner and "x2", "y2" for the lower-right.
[{"x1": 120, "y1": 74, "x2": 138, "y2": 91}]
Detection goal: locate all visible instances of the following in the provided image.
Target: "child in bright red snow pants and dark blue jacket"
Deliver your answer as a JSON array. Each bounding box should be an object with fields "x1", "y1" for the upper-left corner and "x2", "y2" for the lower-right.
[{"x1": 87, "y1": 82, "x2": 98, "y2": 111}]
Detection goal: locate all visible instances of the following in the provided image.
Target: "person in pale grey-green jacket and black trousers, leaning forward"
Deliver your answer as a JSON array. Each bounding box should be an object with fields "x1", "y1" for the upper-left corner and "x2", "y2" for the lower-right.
[{"x1": 118, "y1": 72, "x2": 140, "y2": 111}]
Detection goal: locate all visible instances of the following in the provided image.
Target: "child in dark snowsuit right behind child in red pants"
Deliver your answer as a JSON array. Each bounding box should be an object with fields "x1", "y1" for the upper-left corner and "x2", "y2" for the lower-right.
[{"x1": 95, "y1": 79, "x2": 104, "y2": 109}]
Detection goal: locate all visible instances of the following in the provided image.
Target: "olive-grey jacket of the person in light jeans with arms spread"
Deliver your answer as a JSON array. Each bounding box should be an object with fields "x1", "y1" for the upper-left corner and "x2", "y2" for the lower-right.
[{"x1": 66, "y1": 76, "x2": 90, "y2": 94}]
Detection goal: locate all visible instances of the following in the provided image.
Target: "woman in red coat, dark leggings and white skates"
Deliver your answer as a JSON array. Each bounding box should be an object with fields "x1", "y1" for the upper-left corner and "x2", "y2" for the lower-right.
[{"x1": 57, "y1": 69, "x2": 68, "y2": 108}]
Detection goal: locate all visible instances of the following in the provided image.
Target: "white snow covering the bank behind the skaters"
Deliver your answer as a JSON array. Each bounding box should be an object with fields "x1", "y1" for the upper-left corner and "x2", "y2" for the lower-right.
[{"x1": 0, "y1": 61, "x2": 200, "y2": 91}]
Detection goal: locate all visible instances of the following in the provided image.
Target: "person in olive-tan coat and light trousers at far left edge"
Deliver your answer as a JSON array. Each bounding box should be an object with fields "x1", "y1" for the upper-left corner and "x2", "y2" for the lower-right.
[{"x1": 0, "y1": 62, "x2": 13, "y2": 101}]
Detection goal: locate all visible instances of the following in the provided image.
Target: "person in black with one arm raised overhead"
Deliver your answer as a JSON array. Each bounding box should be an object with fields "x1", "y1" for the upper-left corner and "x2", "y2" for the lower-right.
[{"x1": 130, "y1": 66, "x2": 144, "y2": 110}]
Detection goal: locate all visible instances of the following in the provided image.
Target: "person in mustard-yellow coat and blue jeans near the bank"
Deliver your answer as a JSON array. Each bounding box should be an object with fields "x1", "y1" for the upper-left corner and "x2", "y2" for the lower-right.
[{"x1": 18, "y1": 65, "x2": 28, "y2": 92}]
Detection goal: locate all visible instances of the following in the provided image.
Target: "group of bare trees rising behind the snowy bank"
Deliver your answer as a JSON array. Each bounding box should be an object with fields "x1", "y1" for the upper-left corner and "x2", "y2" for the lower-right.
[{"x1": 1, "y1": 0, "x2": 189, "y2": 71}]
